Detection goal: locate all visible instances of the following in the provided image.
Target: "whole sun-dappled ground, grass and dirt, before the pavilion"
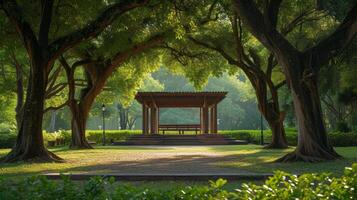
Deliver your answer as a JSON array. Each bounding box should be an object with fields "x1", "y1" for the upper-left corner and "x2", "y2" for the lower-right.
[{"x1": 0, "y1": 145, "x2": 357, "y2": 177}]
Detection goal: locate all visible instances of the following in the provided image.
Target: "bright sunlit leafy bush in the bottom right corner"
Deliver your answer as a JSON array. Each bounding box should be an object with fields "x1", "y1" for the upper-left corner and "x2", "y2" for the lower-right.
[{"x1": 233, "y1": 164, "x2": 357, "y2": 200}]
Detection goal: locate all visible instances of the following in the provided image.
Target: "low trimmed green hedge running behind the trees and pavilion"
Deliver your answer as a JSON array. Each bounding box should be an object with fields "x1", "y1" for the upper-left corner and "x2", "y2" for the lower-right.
[{"x1": 0, "y1": 128, "x2": 357, "y2": 148}]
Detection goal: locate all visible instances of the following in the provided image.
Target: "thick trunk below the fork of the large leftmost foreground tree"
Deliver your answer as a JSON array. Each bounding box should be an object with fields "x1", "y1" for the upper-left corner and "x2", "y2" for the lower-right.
[{"x1": 3, "y1": 60, "x2": 62, "y2": 162}]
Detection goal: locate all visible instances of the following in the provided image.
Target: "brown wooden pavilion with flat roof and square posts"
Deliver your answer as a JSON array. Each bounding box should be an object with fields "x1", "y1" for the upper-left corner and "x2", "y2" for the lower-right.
[{"x1": 135, "y1": 92, "x2": 227, "y2": 134}]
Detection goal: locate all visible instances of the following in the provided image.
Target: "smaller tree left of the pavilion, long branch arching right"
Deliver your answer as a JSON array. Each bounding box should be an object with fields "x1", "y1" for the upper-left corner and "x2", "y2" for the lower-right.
[{"x1": 60, "y1": 35, "x2": 163, "y2": 148}]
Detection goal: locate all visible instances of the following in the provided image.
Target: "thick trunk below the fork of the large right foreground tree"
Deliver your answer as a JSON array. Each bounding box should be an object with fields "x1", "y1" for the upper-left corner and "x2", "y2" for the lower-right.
[{"x1": 277, "y1": 59, "x2": 341, "y2": 162}]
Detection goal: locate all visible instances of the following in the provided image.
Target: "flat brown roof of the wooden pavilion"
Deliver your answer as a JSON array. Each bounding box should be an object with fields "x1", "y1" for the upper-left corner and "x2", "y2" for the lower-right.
[{"x1": 135, "y1": 91, "x2": 227, "y2": 107}]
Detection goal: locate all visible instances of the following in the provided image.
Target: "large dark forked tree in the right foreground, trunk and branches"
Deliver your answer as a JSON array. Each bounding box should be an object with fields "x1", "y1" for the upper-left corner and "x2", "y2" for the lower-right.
[{"x1": 233, "y1": 0, "x2": 357, "y2": 162}]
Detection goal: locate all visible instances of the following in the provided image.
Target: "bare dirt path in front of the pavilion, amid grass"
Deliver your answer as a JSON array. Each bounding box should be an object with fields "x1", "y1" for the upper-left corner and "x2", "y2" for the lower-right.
[{"x1": 62, "y1": 147, "x2": 252, "y2": 174}]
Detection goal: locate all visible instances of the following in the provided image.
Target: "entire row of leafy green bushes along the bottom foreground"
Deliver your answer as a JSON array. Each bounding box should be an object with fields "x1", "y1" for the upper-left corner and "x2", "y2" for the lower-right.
[{"x1": 0, "y1": 164, "x2": 357, "y2": 200}]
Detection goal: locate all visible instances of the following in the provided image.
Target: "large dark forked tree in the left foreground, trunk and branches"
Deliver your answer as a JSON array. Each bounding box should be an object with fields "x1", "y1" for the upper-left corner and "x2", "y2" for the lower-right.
[{"x1": 0, "y1": 0, "x2": 147, "y2": 162}]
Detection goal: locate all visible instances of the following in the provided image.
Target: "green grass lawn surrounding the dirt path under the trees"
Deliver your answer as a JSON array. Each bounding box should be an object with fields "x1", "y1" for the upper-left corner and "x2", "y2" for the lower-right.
[{"x1": 0, "y1": 145, "x2": 357, "y2": 178}]
